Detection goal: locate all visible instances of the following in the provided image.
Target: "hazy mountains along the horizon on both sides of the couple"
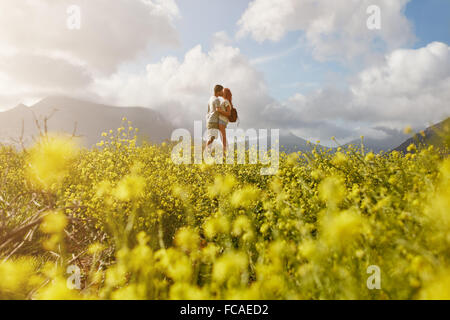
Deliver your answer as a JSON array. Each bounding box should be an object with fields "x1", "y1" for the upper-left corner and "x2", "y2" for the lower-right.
[{"x1": 0, "y1": 96, "x2": 450, "y2": 152}]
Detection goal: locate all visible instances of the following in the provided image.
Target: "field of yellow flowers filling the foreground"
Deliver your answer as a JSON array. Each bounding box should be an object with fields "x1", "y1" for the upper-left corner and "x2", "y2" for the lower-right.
[{"x1": 0, "y1": 120, "x2": 450, "y2": 299}]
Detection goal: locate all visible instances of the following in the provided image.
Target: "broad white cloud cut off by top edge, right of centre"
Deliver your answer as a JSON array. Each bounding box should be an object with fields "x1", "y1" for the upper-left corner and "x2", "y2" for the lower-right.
[{"x1": 237, "y1": 0, "x2": 414, "y2": 61}]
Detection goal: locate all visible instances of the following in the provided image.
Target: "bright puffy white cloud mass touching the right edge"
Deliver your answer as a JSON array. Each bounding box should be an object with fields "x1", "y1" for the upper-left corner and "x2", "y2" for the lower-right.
[{"x1": 350, "y1": 42, "x2": 450, "y2": 125}]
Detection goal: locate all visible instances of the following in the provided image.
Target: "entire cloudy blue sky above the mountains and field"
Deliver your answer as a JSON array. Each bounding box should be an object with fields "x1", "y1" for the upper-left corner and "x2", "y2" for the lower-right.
[{"x1": 0, "y1": 0, "x2": 450, "y2": 144}]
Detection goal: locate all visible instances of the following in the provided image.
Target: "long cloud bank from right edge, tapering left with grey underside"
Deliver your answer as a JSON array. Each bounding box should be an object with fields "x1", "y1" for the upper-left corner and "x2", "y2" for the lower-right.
[{"x1": 263, "y1": 42, "x2": 450, "y2": 139}]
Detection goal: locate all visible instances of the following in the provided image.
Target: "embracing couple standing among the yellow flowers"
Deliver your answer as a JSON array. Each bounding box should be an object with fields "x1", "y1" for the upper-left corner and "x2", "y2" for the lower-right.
[{"x1": 206, "y1": 85, "x2": 237, "y2": 156}]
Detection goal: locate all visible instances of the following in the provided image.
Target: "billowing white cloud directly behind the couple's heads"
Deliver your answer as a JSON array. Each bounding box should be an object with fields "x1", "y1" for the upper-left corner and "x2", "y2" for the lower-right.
[{"x1": 94, "y1": 44, "x2": 273, "y2": 126}]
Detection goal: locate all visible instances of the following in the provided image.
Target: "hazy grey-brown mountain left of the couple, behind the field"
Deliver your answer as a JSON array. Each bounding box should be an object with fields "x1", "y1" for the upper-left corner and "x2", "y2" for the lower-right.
[{"x1": 0, "y1": 97, "x2": 173, "y2": 147}]
